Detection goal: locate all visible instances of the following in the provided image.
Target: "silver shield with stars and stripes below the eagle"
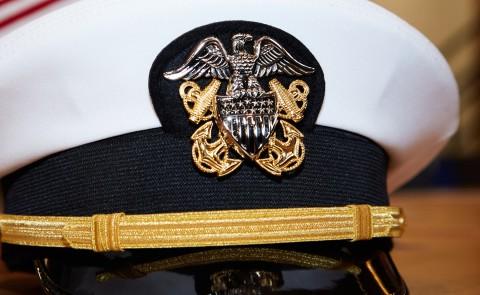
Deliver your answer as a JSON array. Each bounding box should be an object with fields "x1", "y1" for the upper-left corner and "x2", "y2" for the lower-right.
[{"x1": 216, "y1": 92, "x2": 278, "y2": 159}]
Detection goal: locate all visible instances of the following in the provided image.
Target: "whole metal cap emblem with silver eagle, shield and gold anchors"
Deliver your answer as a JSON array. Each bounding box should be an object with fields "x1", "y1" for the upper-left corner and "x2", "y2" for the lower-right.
[{"x1": 164, "y1": 33, "x2": 315, "y2": 176}]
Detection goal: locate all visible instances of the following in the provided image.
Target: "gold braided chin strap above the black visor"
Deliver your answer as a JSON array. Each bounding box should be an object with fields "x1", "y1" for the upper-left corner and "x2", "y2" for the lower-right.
[{"x1": 0, "y1": 205, "x2": 405, "y2": 252}]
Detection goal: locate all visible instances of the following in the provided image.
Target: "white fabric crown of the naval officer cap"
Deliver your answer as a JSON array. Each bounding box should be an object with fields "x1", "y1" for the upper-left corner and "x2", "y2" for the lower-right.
[{"x1": 0, "y1": 0, "x2": 458, "y2": 191}]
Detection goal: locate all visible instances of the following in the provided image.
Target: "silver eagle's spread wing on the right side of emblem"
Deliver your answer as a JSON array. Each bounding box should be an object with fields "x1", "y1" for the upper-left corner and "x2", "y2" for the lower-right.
[{"x1": 254, "y1": 36, "x2": 315, "y2": 78}]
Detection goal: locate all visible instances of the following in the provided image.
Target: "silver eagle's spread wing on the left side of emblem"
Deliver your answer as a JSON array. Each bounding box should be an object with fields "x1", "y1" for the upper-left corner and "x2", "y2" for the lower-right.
[{"x1": 163, "y1": 37, "x2": 230, "y2": 80}]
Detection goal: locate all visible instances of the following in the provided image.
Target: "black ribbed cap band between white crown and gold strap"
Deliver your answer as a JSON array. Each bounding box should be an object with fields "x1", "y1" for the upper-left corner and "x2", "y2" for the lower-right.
[{"x1": 4, "y1": 126, "x2": 388, "y2": 216}]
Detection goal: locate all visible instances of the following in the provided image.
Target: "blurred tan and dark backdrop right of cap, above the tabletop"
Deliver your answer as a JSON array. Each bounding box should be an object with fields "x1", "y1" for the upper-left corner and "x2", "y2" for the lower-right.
[{"x1": 373, "y1": 0, "x2": 480, "y2": 189}]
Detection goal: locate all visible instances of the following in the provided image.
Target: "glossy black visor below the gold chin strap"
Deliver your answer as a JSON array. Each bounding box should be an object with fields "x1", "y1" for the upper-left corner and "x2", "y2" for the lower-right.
[{"x1": 36, "y1": 240, "x2": 408, "y2": 295}]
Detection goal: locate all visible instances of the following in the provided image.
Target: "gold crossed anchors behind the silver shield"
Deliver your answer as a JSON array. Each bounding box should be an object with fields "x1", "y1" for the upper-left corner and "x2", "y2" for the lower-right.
[{"x1": 179, "y1": 79, "x2": 309, "y2": 176}]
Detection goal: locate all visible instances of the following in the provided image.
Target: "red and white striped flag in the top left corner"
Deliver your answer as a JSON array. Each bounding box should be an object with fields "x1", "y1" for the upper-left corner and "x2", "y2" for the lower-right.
[{"x1": 0, "y1": 0, "x2": 71, "y2": 34}]
